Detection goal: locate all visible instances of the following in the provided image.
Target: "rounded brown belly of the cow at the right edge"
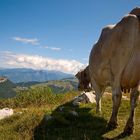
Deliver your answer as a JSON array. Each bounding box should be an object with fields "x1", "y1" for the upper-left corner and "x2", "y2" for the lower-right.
[{"x1": 121, "y1": 52, "x2": 140, "y2": 89}]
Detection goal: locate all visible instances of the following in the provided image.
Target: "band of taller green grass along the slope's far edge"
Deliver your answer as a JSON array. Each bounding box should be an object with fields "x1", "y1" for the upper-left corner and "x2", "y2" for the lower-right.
[{"x1": 0, "y1": 87, "x2": 76, "y2": 108}]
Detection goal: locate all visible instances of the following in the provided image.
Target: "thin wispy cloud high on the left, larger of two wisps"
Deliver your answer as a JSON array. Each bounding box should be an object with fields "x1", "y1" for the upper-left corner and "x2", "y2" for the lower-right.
[{"x1": 12, "y1": 37, "x2": 39, "y2": 45}]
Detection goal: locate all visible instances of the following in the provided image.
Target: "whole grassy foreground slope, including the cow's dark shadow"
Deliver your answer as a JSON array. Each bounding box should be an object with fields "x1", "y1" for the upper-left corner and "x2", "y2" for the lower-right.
[{"x1": 0, "y1": 89, "x2": 140, "y2": 140}]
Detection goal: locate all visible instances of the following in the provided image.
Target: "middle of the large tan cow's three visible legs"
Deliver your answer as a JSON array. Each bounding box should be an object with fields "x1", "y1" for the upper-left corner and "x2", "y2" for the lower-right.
[{"x1": 107, "y1": 87, "x2": 122, "y2": 130}]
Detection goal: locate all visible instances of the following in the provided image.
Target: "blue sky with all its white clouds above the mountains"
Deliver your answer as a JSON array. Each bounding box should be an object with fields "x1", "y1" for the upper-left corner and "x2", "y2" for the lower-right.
[{"x1": 0, "y1": 0, "x2": 140, "y2": 73}]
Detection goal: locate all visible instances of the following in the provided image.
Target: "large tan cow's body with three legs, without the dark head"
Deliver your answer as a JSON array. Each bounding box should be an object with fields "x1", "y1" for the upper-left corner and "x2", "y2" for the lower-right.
[{"x1": 76, "y1": 8, "x2": 140, "y2": 135}]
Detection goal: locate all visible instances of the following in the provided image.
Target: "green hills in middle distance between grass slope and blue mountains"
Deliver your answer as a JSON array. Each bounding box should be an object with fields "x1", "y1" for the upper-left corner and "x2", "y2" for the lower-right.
[{"x1": 0, "y1": 77, "x2": 78, "y2": 98}]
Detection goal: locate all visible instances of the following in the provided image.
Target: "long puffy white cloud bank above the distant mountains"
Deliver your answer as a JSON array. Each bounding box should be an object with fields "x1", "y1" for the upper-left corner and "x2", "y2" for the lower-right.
[{"x1": 1, "y1": 52, "x2": 86, "y2": 74}]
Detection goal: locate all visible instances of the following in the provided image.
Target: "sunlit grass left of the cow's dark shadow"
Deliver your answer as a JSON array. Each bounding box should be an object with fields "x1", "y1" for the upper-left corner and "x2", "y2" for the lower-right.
[{"x1": 0, "y1": 87, "x2": 77, "y2": 140}]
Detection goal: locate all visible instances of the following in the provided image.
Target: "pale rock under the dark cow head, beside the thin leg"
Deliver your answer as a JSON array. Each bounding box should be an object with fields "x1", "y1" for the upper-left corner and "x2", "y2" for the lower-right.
[{"x1": 72, "y1": 92, "x2": 96, "y2": 105}]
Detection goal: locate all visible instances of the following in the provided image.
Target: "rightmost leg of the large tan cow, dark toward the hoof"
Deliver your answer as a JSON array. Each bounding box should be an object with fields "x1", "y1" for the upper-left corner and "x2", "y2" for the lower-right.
[{"x1": 123, "y1": 88, "x2": 139, "y2": 135}]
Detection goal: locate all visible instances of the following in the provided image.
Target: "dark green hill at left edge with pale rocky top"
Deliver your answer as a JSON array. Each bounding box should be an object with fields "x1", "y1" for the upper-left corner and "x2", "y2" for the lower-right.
[{"x1": 0, "y1": 77, "x2": 16, "y2": 98}]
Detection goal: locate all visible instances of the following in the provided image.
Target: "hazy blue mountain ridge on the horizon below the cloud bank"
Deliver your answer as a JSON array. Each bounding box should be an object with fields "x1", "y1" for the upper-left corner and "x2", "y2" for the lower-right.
[{"x1": 0, "y1": 68, "x2": 74, "y2": 83}]
